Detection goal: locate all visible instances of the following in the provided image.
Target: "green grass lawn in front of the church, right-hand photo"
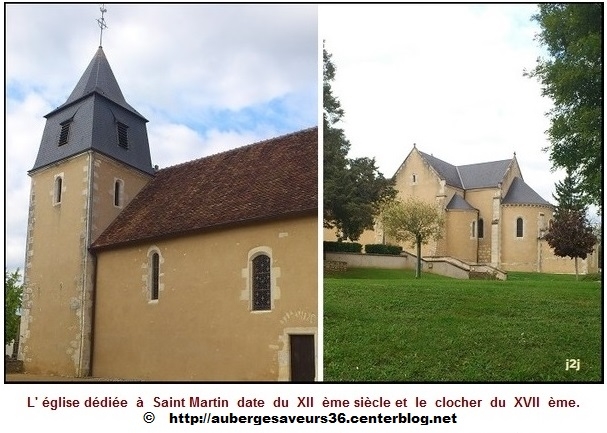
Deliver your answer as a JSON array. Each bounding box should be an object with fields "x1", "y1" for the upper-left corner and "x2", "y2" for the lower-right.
[{"x1": 323, "y1": 269, "x2": 603, "y2": 382}]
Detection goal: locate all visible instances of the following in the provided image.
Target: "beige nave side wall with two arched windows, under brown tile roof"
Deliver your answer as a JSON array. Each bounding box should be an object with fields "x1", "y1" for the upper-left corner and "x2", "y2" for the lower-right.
[{"x1": 93, "y1": 216, "x2": 318, "y2": 381}]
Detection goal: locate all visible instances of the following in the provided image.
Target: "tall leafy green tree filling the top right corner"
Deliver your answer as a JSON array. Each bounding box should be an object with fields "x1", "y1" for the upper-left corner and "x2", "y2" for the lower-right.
[{"x1": 525, "y1": 3, "x2": 603, "y2": 206}]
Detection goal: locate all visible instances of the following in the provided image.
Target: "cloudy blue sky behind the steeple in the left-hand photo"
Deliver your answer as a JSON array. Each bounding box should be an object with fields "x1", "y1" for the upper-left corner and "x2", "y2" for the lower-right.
[{"x1": 5, "y1": 4, "x2": 319, "y2": 270}]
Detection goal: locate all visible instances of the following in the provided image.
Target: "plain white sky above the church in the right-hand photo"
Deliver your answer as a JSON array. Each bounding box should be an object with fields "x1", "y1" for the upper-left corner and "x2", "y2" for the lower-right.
[{"x1": 319, "y1": 4, "x2": 565, "y2": 204}]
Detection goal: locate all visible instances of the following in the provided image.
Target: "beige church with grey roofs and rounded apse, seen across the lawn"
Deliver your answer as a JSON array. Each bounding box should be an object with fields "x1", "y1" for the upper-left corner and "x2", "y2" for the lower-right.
[{"x1": 325, "y1": 145, "x2": 598, "y2": 273}]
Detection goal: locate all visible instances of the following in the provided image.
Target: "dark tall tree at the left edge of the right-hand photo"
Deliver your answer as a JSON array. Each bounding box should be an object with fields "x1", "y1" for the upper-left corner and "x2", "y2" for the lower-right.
[{"x1": 323, "y1": 44, "x2": 396, "y2": 241}]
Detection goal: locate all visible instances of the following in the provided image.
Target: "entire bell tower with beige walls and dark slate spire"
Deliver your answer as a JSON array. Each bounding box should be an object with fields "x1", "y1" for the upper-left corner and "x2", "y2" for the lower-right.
[{"x1": 20, "y1": 37, "x2": 154, "y2": 377}]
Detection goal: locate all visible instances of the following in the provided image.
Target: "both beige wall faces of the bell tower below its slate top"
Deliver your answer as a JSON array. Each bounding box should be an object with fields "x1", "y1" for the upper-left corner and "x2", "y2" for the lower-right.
[{"x1": 19, "y1": 152, "x2": 154, "y2": 376}]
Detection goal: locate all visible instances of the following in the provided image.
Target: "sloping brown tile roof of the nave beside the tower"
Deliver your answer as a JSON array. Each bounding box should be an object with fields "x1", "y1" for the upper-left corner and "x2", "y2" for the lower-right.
[{"x1": 91, "y1": 127, "x2": 318, "y2": 249}]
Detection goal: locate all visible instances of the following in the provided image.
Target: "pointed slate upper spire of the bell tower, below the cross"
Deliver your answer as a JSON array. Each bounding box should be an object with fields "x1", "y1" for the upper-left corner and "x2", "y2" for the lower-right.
[{"x1": 50, "y1": 47, "x2": 143, "y2": 117}]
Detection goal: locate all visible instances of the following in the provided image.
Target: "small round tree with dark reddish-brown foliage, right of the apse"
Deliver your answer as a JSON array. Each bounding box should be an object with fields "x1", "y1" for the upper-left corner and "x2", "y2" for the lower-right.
[{"x1": 545, "y1": 209, "x2": 597, "y2": 280}]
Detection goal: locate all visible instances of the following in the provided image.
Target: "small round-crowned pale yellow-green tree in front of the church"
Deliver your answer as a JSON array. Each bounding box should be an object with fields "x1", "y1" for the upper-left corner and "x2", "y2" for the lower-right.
[{"x1": 382, "y1": 197, "x2": 444, "y2": 278}]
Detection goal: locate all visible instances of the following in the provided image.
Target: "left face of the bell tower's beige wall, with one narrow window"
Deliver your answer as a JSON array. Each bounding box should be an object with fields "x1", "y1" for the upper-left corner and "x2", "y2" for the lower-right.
[{"x1": 20, "y1": 154, "x2": 89, "y2": 375}]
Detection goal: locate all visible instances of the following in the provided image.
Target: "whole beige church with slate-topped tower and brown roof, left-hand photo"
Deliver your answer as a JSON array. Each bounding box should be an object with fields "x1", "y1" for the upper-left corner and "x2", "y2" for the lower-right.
[{"x1": 19, "y1": 47, "x2": 318, "y2": 381}]
